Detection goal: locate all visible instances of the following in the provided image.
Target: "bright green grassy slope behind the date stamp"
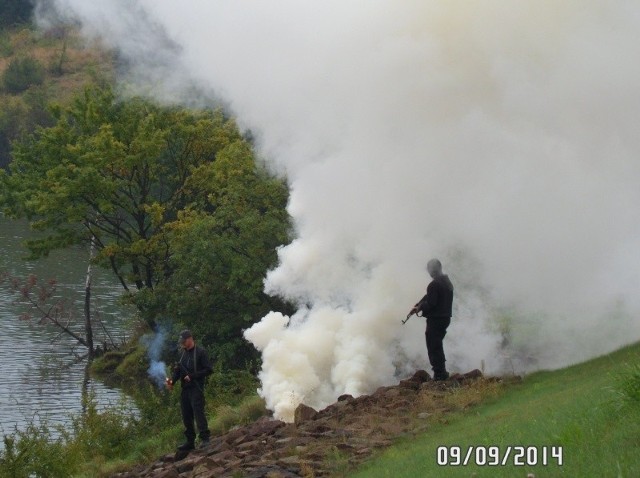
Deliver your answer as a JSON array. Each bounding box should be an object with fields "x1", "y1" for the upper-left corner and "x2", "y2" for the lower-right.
[{"x1": 352, "y1": 344, "x2": 640, "y2": 478}]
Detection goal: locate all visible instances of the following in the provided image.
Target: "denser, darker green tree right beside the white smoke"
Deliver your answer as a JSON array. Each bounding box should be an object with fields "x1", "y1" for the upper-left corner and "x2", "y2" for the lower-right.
[{"x1": 144, "y1": 141, "x2": 291, "y2": 367}]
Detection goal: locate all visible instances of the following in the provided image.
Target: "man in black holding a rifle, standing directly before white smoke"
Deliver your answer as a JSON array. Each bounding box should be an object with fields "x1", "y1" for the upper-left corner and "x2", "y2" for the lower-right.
[{"x1": 411, "y1": 259, "x2": 453, "y2": 380}]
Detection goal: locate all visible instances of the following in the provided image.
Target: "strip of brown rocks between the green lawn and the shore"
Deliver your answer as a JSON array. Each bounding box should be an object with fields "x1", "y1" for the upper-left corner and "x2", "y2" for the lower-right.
[{"x1": 115, "y1": 370, "x2": 487, "y2": 478}]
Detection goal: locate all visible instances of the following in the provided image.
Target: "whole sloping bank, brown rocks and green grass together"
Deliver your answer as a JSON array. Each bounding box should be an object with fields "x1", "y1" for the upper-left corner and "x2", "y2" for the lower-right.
[{"x1": 110, "y1": 344, "x2": 640, "y2": 478}]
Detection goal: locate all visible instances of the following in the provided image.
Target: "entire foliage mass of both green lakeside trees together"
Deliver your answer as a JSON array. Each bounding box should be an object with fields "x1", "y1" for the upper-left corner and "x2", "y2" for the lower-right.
[{"x1": 0, "y1": 88, "x2": 289, "y2": 365}]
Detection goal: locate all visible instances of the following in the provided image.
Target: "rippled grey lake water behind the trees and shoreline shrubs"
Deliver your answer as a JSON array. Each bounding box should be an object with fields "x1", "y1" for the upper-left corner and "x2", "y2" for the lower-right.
[{"x1": 0, "y1": 215, "x2": 131, "y2": 440}]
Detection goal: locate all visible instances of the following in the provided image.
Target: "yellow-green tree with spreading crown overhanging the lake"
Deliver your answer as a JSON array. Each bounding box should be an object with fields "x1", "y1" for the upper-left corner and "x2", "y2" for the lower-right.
[{"x1": 3, "y1": 88, "x2": 231, "y2": 290}]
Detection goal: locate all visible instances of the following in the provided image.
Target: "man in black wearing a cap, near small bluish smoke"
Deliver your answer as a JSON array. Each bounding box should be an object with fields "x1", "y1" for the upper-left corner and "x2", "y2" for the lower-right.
[{"x1": 166, "y1": 330, "x2": 213, "y2": 451}]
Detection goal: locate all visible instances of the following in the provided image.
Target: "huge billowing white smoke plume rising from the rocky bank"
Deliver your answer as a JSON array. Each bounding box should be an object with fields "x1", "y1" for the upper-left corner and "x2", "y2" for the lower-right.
[{"x1": 37, "y1": 0, "x2": 640, "y2": 420}]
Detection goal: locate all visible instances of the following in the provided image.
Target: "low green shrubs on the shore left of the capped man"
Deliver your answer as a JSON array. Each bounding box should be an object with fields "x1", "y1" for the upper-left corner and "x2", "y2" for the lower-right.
[{"x1": 0, "y1": 385, "x2": 180, "y2": 478}]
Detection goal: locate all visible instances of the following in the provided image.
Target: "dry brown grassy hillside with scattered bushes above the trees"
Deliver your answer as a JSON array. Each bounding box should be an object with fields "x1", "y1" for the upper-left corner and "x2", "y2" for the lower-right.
[{"x1": 0, "y1": 25, "x2": 114, "y2": 167}]
